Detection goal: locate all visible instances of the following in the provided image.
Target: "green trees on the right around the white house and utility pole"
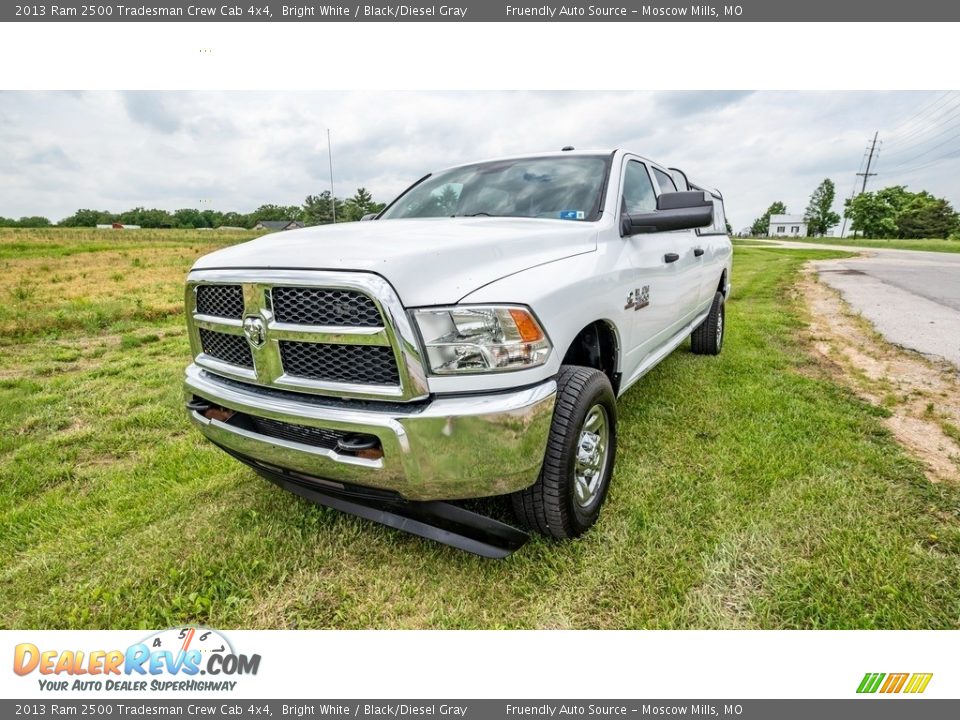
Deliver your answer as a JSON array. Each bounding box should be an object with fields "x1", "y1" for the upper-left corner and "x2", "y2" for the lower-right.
[{"x1": 750, "y1": 178, "x2": 960, "y2": 238}]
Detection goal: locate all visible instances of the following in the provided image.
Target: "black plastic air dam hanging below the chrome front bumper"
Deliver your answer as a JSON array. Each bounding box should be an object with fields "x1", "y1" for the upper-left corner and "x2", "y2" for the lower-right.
[{"x1": 221, "y1": 446, "x2": 530, "y2": 559}]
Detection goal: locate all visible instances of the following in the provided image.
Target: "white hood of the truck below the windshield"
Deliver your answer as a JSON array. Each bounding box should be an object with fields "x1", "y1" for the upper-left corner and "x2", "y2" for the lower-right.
[{"x1": 193, "y1": 217, "x2": 597, "y2": 307}]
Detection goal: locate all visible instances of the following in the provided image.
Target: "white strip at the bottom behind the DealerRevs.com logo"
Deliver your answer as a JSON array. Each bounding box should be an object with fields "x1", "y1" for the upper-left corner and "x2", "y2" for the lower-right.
[{"x1": 0, "y1": 630, "x2": 960, "y2": 701}]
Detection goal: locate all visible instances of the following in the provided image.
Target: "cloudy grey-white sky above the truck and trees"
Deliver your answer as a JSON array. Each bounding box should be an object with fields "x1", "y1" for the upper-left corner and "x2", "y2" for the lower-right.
[{"x1": 0, "y1": 91, "x2": 960, "y2": 230}]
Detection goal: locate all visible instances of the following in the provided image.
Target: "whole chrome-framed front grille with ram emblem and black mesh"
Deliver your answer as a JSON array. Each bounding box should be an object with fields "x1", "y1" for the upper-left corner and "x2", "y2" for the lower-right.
[{"x1": 185, "y1": 269, "x2": 429, "y2": 402}]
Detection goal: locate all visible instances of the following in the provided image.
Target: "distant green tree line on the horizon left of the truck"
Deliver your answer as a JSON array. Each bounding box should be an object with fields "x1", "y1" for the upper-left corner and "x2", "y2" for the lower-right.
[{"x1": 0, "y1": 188, "x2": 384, "y2": 230}]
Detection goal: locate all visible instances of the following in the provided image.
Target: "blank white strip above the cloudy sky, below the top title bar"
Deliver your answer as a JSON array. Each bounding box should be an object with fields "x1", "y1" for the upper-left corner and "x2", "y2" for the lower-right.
[{"x1": 0, "y1": 22, "x2": 957, "y2": 90}]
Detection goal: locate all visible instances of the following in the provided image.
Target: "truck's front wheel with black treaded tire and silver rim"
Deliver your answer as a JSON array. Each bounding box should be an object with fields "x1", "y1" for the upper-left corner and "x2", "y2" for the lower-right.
[{"x1": 512, "y1": 365, "x2": 617, "y2": 539}]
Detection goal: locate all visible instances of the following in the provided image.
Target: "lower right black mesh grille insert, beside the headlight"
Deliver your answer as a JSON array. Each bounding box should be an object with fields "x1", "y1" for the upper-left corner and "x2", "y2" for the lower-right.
[{"x1": 280, "y1": 340, "x2": 400, "y2": 385}]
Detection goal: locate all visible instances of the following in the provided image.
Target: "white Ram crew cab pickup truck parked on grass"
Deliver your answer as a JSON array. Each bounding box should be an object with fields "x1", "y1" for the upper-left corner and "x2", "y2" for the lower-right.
[{"x1": 185, "y1": 148, "x2": 731, "y2": 557}]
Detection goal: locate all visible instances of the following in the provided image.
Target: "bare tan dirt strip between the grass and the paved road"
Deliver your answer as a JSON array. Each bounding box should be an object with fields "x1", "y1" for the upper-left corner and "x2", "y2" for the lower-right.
[{"x1": 797, "y1": 266, "x2": 960, "y2": 483}]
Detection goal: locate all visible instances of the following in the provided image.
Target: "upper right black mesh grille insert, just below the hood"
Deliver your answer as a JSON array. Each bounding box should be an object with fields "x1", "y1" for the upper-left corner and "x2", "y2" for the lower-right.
[{"x1": 271, "y1": 286, "x2": 383, "y2": 327}]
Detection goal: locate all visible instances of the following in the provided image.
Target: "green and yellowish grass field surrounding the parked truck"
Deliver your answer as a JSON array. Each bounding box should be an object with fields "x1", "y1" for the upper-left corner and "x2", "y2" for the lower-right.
[{"x1": 0, "y1": 230, "x2": 960, "y2": 628}]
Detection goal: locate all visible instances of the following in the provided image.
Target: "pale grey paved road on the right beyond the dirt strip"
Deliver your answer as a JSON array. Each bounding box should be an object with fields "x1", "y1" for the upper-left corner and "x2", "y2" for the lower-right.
[{"x1": 752, "y1": 241, "x2": 960, "y2": 367}]
